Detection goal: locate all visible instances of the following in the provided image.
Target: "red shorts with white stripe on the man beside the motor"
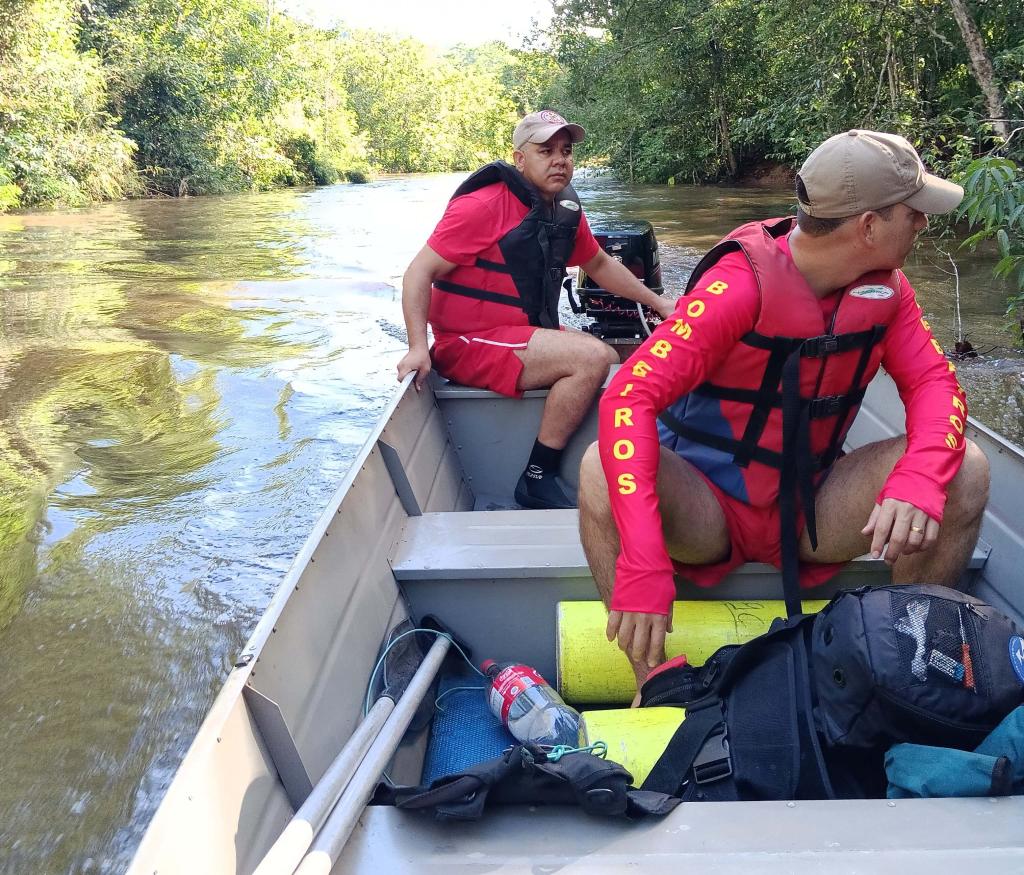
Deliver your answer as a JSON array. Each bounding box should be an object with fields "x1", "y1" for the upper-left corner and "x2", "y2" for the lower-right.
[{"x1": 430, "y1": 325, "x2": 537, "y2": 398}]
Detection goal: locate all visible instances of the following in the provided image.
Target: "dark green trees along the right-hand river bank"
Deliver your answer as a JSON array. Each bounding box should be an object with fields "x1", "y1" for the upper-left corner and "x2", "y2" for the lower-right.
[{"x1": 547, "y1": 0, "x2": 1024, "y2": 321}]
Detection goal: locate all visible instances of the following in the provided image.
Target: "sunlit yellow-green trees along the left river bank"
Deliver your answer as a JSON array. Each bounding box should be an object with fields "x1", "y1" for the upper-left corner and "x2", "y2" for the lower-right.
[{"x1": 0, "y1": 0, "x2": 554, "y2": 211}]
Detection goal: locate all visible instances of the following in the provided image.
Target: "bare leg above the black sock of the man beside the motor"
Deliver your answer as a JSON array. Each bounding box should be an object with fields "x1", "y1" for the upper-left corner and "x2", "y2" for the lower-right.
[{"x1": 516, "y1": 328, "x2": 618, "y2": 450}]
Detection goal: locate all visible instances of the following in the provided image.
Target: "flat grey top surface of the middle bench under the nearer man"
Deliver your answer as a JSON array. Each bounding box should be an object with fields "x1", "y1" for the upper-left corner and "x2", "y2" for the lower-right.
[{"x1": 391, "y1": 509, "x2": 988, "y2": 598}]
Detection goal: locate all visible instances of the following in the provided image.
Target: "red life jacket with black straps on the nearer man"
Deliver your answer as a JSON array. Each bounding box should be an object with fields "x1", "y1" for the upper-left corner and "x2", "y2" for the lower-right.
[{"x1": 658, "y1": 217, "x2": 900, "y2": 614}]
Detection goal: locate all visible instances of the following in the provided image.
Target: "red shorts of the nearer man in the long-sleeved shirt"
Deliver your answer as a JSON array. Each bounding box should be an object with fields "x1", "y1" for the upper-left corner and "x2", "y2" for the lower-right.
[{"x1": 672, "y1": 470, "x2": 847, "y2": 589}]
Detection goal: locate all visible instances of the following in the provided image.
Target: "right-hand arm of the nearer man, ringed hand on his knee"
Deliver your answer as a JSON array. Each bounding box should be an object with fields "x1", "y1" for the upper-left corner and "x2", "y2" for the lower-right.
[{"x1": 861, "y1": 272, "x2": 967, "y2": 565}]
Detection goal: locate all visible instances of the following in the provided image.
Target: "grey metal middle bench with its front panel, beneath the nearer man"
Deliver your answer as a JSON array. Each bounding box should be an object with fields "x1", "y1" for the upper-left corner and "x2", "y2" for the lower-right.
[{"x1": 390, "y1": 509, "x2": 987, "y2": 678}]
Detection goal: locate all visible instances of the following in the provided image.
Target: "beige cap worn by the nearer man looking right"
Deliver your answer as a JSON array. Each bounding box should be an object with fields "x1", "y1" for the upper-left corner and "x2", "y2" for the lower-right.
[{"x1": 799, "y1": 130, "x2": 964, "y2": 218}]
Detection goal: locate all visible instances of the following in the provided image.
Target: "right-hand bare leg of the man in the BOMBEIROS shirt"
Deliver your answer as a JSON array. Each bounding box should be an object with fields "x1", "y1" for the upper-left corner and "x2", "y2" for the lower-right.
[{"x1": 800, "y1": 438, "x2": 988, "y2": 586}]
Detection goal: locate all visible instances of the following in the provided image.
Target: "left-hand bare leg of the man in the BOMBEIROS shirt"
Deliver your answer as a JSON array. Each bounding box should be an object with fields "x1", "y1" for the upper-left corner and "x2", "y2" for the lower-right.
[{"x1": 580, "y1": 444, "x2": 729, "y2": 690}]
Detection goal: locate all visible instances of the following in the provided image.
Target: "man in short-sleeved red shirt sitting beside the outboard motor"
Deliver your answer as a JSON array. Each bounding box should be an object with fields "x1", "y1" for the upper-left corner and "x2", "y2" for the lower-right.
[{"x1": 398, "y1": 110, "x2": 672, "y2": 508}]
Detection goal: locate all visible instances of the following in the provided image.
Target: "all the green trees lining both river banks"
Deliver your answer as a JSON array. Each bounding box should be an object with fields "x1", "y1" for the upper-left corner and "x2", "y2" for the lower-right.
[{"x1": 0, "y1": 0, "x2": 1024, "y2": 327}]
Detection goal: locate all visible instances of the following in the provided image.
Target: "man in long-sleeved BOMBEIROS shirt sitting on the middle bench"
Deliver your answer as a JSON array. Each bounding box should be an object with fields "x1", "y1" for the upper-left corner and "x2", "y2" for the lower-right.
[{"x1": 580, "y1": 130, "x2": 988, "y2": 685}]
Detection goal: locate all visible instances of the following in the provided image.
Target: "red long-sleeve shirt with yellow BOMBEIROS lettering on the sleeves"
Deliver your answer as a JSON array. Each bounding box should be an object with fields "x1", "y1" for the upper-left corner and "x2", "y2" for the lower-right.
[{"x1": 598, "y1": 238, "x2": 967, "y2": 614}]
